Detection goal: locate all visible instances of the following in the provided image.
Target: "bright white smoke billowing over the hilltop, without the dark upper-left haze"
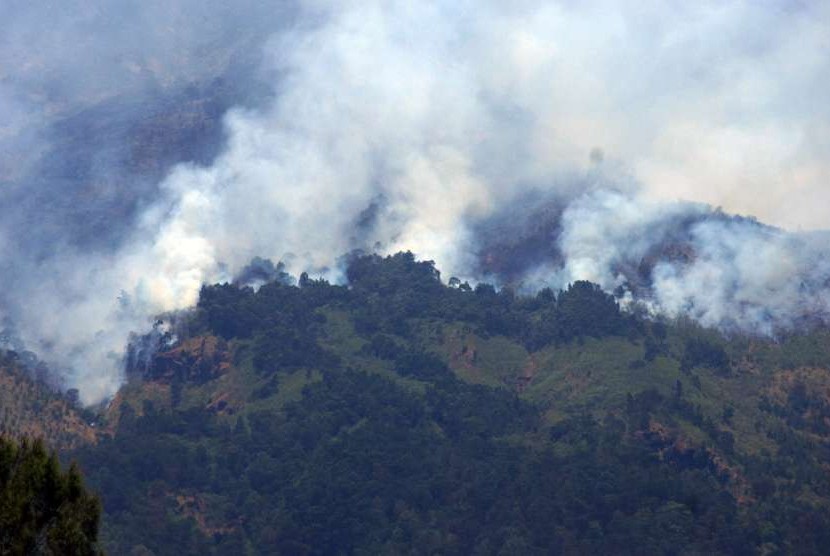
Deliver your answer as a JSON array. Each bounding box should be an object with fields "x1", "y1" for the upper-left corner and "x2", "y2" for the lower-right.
[{"x1": 0, "y1": 0, "x2": 830, "y2": 402}]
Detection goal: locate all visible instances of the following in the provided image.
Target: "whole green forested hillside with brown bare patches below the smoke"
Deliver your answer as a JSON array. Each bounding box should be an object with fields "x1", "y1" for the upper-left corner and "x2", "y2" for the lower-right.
[{"x1": 61, "y1": 253, "x2": 830, "y2": 555}]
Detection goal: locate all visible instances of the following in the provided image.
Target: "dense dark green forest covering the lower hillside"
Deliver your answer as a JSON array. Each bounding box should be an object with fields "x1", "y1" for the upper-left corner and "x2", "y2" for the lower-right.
[{"x1": 82, "y1": 370, "x2": 750, "y2": 554}]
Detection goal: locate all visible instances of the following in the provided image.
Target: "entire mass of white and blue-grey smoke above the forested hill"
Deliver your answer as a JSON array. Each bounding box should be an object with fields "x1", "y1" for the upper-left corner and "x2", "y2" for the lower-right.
[{"x1": 0, "y1": 0, "x2": 830, "y2": 402}]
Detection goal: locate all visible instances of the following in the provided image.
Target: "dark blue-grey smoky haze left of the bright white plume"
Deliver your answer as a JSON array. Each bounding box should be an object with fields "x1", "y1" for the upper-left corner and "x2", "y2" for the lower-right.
[{"x1": 0, "y1": 0, "x2": 292, "y2": 251}]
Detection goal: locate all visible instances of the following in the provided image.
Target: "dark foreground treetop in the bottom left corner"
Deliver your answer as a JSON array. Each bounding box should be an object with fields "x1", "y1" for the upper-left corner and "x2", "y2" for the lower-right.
[{"x1": 0, "y1": 438, "x2": 100, "y2": 555}]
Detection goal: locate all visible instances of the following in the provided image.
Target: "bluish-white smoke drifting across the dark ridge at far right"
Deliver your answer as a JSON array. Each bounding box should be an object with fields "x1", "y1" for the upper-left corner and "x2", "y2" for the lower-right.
[{"x1": 490, "y1": 189, "x2": 830, "y2": 336}]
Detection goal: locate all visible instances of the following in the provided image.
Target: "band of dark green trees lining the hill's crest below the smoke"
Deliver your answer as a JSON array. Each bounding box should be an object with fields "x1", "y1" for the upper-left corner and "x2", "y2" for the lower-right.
[{"x1": 198, "y1": 252, "x2": 644, "y2": 362}]
